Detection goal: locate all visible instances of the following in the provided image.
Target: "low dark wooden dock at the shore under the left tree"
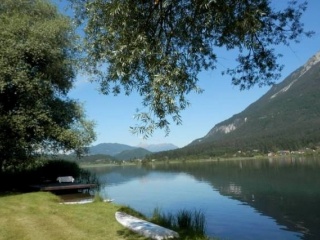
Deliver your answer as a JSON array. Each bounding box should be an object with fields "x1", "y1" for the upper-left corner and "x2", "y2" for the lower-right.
[{"x1": 30, "y1": 183, "x2": 96, "y2": 192}]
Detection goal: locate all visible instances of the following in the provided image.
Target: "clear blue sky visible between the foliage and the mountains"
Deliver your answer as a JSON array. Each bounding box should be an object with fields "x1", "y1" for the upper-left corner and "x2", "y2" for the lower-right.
[{"x1": 56, "y1": 0, "x2": 320, "y2": 147}]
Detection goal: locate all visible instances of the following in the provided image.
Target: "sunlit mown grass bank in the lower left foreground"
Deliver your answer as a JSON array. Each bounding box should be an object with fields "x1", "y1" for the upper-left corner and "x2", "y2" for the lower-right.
[{"x1": 0, "y1": 193, "x2": 144, "y2": 240}]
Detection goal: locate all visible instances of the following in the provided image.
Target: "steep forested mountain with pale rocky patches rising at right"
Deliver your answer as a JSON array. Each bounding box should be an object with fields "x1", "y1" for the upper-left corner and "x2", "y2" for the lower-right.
[{"x1": 151, "y1": 52, "x2": 320, "y2": 157}]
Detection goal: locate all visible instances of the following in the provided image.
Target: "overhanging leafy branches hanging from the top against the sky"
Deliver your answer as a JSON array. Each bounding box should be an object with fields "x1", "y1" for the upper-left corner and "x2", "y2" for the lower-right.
[{"x1": 69, "y1": 0, "x2": 312, "y2": 136}]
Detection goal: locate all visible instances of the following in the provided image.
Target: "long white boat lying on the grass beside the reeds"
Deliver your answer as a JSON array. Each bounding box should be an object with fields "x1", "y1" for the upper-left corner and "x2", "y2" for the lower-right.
[{"x1": 115, "y1": 212, "x2": 179, "y2": 240}]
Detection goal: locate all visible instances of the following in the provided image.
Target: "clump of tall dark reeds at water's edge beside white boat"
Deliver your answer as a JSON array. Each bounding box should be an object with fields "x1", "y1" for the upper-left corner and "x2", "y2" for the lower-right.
[{"x1": 151, "y1": 208, "x2": 208, "y2": 239}]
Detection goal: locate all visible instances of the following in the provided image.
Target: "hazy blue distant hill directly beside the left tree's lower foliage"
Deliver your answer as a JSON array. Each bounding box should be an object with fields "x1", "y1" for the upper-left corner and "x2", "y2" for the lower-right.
[{"x1": 89, "y1": 143, "x2": 136, "y2": 156}]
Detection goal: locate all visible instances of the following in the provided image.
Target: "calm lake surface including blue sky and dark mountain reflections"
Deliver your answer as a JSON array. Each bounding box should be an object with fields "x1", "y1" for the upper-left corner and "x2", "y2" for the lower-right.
[{"x1": 92, "y1": 159, "x2": 320, "y2": 240}]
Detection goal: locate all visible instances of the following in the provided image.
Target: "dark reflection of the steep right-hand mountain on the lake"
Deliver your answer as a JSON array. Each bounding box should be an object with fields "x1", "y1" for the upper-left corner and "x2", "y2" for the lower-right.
[{"x1": 152, "y1": 159, "x2": 320, "y2": 239}]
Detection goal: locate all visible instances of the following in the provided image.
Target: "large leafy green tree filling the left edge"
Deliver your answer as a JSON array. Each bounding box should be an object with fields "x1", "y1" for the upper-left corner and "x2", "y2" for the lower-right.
[{"x1": 0, "y1": 0, "x2": 95, "y2": 172}]
